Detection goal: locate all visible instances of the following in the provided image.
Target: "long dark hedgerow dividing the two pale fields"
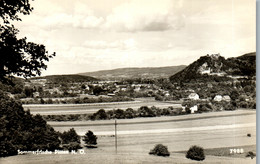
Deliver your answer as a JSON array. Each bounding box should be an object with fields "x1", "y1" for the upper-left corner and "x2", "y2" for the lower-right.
[{"x1": 43, "y1": 97, "x2": 242, "y2": 121}]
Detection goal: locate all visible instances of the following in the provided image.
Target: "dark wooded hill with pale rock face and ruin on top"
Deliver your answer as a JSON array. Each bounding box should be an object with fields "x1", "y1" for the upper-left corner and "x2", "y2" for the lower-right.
[{"x1": 170, "y1": 52, "x2": 256, "y2": 82}]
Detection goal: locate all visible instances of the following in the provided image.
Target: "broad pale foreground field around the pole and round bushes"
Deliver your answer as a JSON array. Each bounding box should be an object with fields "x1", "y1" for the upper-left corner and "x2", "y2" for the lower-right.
[{"x1": 0, "y1": 110, "x2": 256, "y2": 164}]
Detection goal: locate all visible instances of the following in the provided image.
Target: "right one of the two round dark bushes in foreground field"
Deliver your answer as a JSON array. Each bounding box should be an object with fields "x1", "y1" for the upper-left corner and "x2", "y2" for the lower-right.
[{"x1": 186, "y1": 146, "x2": 205, "y2": 161}]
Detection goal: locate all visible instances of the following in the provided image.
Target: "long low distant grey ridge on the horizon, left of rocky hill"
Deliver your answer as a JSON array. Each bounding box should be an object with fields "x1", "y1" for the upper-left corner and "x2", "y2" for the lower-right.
[{"x1": 79, "y1": 65, "x2": 186, "y2": 80}]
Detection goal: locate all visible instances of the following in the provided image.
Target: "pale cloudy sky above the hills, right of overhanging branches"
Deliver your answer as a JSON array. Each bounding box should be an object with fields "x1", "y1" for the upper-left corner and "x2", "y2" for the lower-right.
[{"x1": 14, "y1": 0, "x2": 256, "y2": 75}]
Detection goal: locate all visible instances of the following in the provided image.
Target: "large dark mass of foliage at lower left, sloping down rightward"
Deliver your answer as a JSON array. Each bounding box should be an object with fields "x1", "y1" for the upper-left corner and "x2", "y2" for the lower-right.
[{"x1": 0, "y1": 92, "x2": 60, "y2": 157}]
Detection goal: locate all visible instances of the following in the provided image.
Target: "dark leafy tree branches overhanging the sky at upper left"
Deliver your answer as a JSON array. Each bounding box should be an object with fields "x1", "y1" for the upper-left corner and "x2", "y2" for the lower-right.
[{"x1": 0, "y1": 0, "x2": 55, "y2": 82}]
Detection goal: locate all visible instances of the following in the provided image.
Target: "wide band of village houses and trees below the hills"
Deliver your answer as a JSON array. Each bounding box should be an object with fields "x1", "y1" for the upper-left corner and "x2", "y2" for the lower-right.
[{"x1": 9, "y1": 72, "x2": 252, "y2": 116}]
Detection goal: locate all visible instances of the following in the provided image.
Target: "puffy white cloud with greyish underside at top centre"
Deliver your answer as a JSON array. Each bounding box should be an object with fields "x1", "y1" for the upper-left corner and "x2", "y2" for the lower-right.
[{"x1": 104, "y1": 0, "x2": 184, "y2": 32}]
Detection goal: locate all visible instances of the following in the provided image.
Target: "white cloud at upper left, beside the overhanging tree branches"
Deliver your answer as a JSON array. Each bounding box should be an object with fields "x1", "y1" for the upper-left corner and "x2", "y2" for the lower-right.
[{"x1": 19, "y1": 0, "x2": 104, "y2": 30}]
